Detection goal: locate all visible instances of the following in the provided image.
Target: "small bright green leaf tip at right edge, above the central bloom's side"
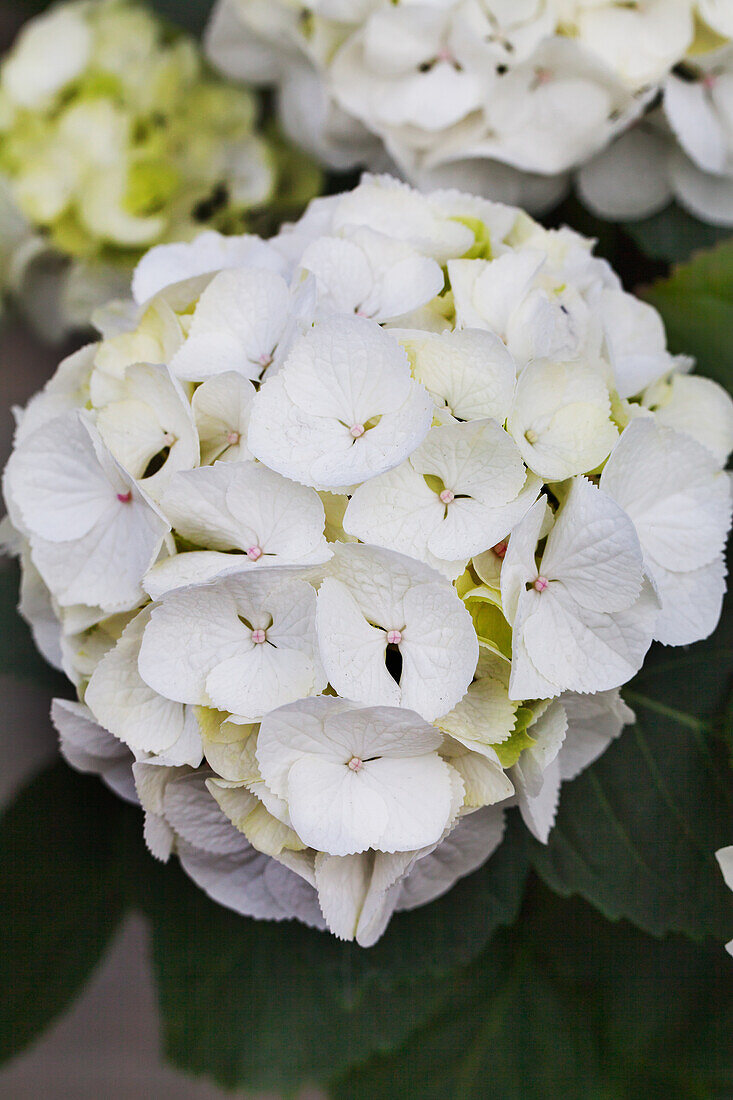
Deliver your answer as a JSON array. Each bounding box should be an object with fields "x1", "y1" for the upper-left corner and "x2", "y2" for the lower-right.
[{"x1": 639, "y1": 239, "x2": 733, "y2": 389}]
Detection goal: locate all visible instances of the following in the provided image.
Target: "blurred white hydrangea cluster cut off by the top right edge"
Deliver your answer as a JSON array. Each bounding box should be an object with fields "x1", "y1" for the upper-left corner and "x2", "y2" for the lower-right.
[{"x1": 203, "y1": 0, "x2": 733, "y2": 226}]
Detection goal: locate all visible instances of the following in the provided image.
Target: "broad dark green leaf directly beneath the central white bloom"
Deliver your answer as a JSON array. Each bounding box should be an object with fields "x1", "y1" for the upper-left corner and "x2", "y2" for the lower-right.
[{"x1": 135, "y1": 823, "x2": 526, "y2": 1089}]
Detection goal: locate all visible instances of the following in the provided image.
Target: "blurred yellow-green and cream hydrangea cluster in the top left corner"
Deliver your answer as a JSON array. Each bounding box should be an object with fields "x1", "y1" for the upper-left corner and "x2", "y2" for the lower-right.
[{"x1": 0, "y1": 0, "x2": 318, "y2": 337}]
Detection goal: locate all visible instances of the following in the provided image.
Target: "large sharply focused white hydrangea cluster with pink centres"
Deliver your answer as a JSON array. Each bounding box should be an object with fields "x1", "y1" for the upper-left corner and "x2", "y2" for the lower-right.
[{"x1": 3, "y1": 176, "x2": 733, "y2": 945}]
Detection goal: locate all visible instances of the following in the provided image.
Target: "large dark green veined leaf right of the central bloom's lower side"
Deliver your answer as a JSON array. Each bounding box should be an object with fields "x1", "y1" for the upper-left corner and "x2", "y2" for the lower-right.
[{"x1": 532, "y1": 554, "x2": 733, "y2": 942}]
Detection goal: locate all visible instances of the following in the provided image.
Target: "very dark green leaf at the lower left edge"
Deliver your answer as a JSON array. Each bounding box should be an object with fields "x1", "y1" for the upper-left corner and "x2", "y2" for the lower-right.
[{"x1": 0, "y1": 762, "x2": 123, "y2": 1059}]
